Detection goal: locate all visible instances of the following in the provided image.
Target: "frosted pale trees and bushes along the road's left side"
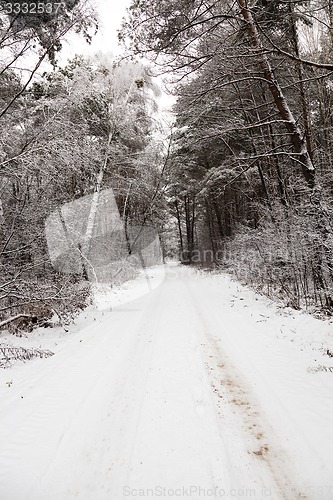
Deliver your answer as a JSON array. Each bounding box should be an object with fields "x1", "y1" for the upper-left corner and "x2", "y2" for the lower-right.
[{"x1": 0, "y1": 2, "x2": 166, "y2": 329}]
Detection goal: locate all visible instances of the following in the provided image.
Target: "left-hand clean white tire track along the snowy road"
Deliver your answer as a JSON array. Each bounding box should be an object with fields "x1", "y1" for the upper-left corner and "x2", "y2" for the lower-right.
[{"x1": 34, "y1": 290, "x2": 166, "y2": 500}]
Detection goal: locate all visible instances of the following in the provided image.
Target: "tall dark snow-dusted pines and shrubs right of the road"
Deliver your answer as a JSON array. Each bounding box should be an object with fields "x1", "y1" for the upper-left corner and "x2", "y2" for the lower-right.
[{"x1": 120, "y1": 0, "x2": 333, "y2": 313}]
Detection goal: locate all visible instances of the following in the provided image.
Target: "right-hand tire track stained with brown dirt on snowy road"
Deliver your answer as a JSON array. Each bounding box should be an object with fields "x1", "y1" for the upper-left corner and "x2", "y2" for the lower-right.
[{"x1": 184, "y1": 279, "x2": 307, "y2": 500}]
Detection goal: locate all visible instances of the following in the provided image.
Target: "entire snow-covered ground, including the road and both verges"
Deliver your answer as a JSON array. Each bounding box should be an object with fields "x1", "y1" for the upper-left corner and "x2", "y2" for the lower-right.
[{"x1": 0, "y1": 265, "x2": 333, "y2": 500}]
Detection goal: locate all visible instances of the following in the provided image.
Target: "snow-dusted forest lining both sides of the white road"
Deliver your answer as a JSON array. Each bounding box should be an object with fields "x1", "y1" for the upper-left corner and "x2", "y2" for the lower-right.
[{"x1": 0, "y1": 0, "x2": 333, "y2": 332}]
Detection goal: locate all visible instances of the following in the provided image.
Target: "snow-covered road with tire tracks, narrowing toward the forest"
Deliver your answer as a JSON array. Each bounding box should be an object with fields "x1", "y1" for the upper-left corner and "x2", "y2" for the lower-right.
[{"x1": 0, "y1": 269, "x2": 316, "y2": 500}]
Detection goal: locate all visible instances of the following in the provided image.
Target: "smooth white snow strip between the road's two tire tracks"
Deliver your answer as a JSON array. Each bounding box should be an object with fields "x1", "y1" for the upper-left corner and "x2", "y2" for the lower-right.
[{"x1": 117, "y1": 266, "x2": 235, "y2": 498}]
